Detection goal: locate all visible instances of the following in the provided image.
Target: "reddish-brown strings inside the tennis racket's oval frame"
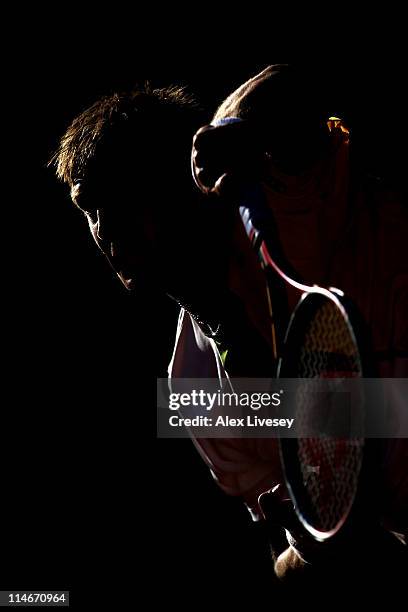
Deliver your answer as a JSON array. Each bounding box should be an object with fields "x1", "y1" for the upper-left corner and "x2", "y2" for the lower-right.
[{"x1": 296, "y1": 301, "x2": 363, "y2": 532}]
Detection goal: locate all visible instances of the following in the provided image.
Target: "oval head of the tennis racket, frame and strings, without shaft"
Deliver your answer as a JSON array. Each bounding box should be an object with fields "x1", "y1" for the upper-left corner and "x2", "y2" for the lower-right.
[{"x1": 278, "y1": 288, "x2": 365, "y2": 541}]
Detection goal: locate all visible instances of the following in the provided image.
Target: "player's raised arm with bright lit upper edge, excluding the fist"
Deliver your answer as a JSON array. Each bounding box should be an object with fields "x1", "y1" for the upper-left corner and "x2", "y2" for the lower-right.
[{"x1": 214, "y1": 64, "x2": 329, "y2": 174}]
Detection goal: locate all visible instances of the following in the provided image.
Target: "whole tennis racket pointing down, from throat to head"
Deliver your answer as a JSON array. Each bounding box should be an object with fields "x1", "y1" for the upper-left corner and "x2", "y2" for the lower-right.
[{"x1": 240, "y1": 180, "x2": 365, "y2": 541}]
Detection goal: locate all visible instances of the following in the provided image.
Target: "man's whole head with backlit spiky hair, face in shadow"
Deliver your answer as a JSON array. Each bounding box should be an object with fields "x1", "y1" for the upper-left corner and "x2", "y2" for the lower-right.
[{"x1": 51, "y1": 85, "x2": 218, "y2": 297}]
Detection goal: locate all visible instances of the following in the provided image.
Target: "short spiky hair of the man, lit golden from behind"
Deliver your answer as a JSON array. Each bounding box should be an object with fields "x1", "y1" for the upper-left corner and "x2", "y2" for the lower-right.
[{"x1": 49, "y1": 84, "x2": 202, "y2": 192}]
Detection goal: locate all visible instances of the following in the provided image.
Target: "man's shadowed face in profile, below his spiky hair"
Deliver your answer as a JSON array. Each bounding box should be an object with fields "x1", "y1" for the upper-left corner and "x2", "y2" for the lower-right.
[{"x1": 71, "y1": 152, "x2": 234, "y2": 320}]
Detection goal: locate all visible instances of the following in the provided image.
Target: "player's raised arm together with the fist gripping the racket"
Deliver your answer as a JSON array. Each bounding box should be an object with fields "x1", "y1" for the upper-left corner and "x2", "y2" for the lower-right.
[{"x1": 194, "y1": 64, "x2": 330, "y2": 194}]
